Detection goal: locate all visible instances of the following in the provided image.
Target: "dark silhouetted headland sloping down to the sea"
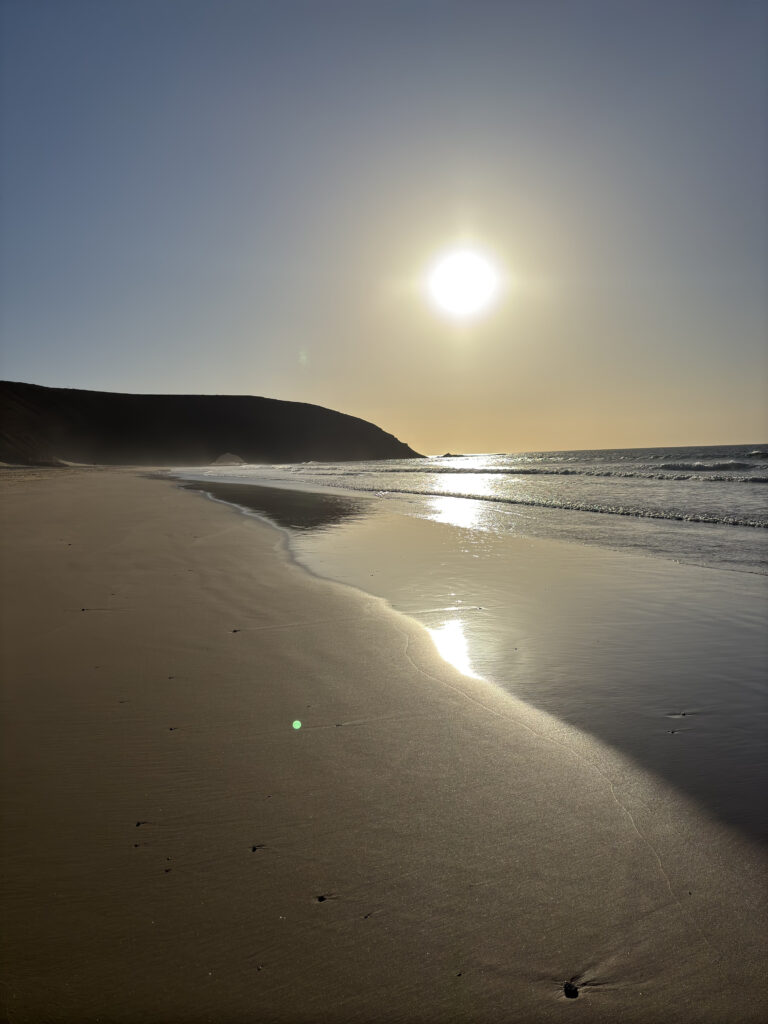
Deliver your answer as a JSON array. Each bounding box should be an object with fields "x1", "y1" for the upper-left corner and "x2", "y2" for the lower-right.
[{"x1": 0, "y1": 381, "x2": 418, "y2": 466}]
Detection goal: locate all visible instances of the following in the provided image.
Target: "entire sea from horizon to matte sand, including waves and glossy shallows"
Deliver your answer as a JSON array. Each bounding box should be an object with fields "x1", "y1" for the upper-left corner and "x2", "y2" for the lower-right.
[{"x1": 174, "y1": 444, "x2": 768, "y2": 843}]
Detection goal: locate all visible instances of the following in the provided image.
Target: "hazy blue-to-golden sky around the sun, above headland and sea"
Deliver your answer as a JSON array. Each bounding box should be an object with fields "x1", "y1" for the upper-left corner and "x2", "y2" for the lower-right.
[{"x1": 0, "y1": 0, "x2": 768, "y2": 454}]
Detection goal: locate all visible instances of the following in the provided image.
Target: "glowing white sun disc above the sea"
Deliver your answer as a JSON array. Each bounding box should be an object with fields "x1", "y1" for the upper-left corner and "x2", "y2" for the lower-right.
[{"x1": 427, "y1": 249, "x2": 499, "y2": 319}]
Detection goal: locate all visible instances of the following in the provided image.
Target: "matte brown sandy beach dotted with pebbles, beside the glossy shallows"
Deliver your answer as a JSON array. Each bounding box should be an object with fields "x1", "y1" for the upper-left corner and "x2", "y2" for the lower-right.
[{"x1": 1, "y1": 470, "x2": 768, "y2": 1024}]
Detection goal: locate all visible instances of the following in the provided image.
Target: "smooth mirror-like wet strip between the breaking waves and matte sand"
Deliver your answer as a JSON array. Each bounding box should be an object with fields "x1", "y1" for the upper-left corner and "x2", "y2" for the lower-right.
[{"x1": 180, "y1": 471, "x2": 768, "y2": 848}]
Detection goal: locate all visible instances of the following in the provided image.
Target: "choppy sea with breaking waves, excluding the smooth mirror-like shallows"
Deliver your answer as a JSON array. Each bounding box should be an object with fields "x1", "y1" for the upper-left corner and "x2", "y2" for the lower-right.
[{"x1": 176, "y1": 444, "x2": 768, "y2": 573}]
